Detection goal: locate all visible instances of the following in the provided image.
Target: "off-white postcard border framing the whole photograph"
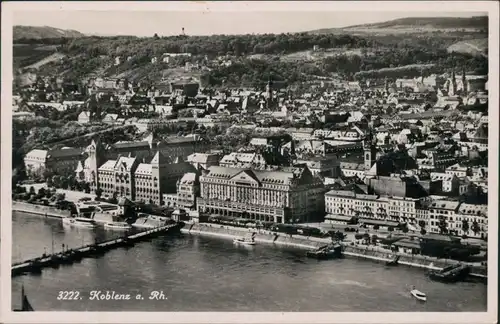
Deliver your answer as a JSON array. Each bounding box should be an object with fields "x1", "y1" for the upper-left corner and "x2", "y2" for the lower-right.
[{"x1": 0, "y1": 1, "x2": 499, "y2": 324}]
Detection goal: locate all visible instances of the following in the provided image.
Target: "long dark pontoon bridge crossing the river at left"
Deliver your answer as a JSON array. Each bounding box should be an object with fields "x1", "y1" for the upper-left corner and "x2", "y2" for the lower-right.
[{"x1": 11, "y1": 223, "x2": 184, "y2": 277}]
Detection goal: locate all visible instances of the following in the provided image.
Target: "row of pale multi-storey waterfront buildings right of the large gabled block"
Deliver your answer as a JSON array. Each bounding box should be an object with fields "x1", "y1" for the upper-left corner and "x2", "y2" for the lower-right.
[{"x1": 325, "y1": 190, "x2": 488, "y2": 238}]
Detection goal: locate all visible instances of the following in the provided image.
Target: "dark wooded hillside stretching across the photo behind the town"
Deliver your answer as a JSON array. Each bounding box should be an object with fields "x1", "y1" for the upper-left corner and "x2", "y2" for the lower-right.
[{"x1": 13, "y1": 21, "x2": 488, "y2": 86}]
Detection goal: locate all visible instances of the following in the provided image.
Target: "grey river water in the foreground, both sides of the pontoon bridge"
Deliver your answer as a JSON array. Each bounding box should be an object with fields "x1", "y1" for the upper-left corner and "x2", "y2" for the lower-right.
[{"x1": 12, "y1": 213, "x2": 487, "y2": 312}]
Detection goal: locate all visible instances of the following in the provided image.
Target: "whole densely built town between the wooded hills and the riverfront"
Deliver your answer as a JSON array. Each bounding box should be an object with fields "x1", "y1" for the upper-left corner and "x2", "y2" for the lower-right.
[{"x1": 13, "y1": 62, "x2": 488, "y2": 243}]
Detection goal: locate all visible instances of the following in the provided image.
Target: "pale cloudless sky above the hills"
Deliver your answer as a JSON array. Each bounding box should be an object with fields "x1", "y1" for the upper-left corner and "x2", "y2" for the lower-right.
[{"x1": 12, "y1": 6, "x2": 481, "y2": 36}]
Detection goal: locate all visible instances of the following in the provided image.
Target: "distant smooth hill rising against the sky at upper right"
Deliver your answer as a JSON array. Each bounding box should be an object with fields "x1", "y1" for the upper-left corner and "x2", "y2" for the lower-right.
[{"x1": 310, "y1": 16, "x2": 488, "y2": 34}]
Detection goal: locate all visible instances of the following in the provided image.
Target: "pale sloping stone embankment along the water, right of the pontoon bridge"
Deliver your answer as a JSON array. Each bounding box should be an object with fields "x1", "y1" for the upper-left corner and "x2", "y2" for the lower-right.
[{"x1": 181, "y1": 223, "x2": 487, "y2": 278}]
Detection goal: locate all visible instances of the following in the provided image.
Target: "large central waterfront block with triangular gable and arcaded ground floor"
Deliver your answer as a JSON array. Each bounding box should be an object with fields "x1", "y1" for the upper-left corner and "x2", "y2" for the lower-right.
[{"x1": 197, "y1": 166, "x2": 324, "y2": 223}]
